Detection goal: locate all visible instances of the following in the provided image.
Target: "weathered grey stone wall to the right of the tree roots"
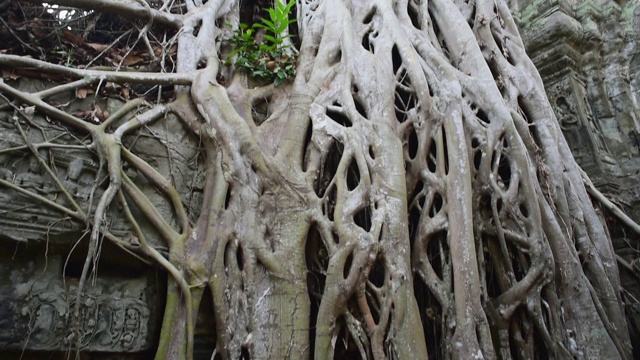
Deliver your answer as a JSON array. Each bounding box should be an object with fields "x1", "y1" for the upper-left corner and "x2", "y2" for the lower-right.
[{"x1": 510, "y1": 0, "x2": 640, "y2": 355}]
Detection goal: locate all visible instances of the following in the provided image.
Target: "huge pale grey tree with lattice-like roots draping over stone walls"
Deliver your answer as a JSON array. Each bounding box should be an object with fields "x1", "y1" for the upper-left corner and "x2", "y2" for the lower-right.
[{"x1": 0, "y1": 0, "x2": 632, "y2": 359}]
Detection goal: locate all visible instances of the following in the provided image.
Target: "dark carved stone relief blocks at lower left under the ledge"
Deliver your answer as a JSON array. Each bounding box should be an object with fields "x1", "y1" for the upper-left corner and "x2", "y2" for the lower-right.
[{"x1": 0, "y1": 256, "x2": 158, "y2": 352}]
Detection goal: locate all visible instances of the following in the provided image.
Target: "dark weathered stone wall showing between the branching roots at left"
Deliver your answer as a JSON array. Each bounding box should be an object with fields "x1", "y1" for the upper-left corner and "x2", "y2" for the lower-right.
[{"x1": 0, "y1": 78, "x2": 202, "y2": 359}]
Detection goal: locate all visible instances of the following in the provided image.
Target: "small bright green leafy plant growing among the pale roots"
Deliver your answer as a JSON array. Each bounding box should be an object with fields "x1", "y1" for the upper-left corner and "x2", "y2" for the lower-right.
[{"x1": 226, "y1": 0, "x2": 296, "y2": 86}]
